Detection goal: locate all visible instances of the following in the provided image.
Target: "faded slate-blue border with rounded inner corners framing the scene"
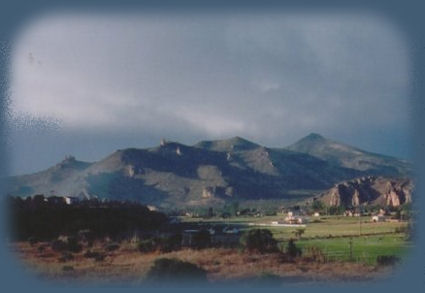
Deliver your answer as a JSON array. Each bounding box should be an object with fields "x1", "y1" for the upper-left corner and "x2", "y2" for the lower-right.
[{"x1": 0, "y1": 0, "x2": 425, "y2": 292}]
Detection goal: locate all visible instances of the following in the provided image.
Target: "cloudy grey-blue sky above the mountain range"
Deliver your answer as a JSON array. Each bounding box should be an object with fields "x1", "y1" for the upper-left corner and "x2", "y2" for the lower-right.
[{"x1": 8, "y1": 12, "x2": 410, "y2": 174}]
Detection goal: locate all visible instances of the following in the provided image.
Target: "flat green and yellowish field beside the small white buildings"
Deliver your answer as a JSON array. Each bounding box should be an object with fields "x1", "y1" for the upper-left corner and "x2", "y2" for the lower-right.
[{"x1": 182, "y1": 216, "x2": 412, "y2": 264}]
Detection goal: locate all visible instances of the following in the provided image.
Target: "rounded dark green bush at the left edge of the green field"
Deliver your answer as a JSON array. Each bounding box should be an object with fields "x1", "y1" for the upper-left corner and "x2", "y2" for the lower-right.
[{"x1": 241, "y1": 229, "x2": 278, "y2": 253}]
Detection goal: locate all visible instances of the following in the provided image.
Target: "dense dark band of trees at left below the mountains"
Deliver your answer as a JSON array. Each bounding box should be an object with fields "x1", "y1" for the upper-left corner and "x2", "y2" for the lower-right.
[{"x1": 6, "y1": 195, "x2": 168, "y2": 241}]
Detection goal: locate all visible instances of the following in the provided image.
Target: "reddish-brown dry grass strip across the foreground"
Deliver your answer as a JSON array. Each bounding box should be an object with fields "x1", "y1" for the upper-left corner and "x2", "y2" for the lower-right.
[{"x1": 12, "y1": 242, "x2": 392, "y2": 283}]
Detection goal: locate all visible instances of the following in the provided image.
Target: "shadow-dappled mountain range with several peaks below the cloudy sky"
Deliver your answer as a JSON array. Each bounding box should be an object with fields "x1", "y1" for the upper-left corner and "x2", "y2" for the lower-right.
[{"x1": 4, "y1": 134, "x2": 411, "y2": 207}]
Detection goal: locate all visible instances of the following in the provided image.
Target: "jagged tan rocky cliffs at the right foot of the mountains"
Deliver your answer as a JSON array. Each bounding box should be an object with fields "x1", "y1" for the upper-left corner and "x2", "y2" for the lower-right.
[{"x1": 321, "y1": 176, "x2": 413, "y2": 207}]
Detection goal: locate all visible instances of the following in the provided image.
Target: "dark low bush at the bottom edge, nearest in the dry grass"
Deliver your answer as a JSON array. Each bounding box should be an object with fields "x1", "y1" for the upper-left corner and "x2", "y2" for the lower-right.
[{"x1": 146, "y1": 258, "x2": 207, "y2": 283}]
